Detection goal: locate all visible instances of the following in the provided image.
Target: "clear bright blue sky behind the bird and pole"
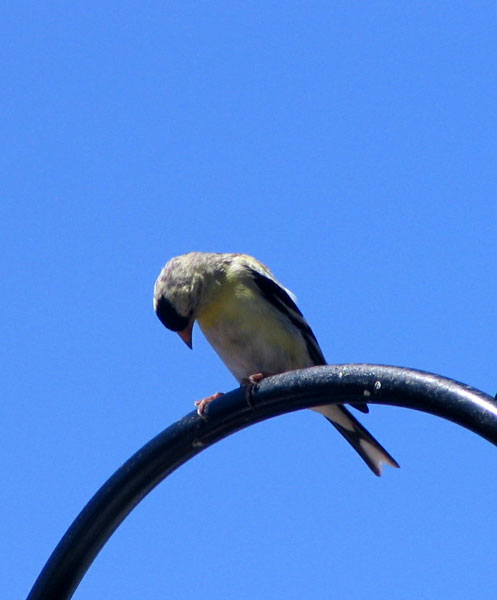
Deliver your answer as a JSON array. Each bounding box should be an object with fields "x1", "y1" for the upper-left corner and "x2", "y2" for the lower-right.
[{"x1": 0, "y1": 1, "x2": 497, "y2": 600}]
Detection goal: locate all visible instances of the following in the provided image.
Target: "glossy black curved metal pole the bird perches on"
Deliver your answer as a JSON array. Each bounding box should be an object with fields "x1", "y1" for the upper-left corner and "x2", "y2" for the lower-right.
[{"x1": 28, "y1": 364, "x2": 497, "y2": 600}]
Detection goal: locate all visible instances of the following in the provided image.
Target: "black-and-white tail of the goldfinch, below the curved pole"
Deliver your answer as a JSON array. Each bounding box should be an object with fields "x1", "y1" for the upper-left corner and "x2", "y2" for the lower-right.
[{"x1": 314, "y1": 404, "x2": 399, "y2": 477}]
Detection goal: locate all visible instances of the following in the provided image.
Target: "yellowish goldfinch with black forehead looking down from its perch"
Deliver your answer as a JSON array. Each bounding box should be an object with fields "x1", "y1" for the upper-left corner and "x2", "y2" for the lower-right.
[{"x1": 154, "y1": 252, "x2": 399, "y2": 475}]
